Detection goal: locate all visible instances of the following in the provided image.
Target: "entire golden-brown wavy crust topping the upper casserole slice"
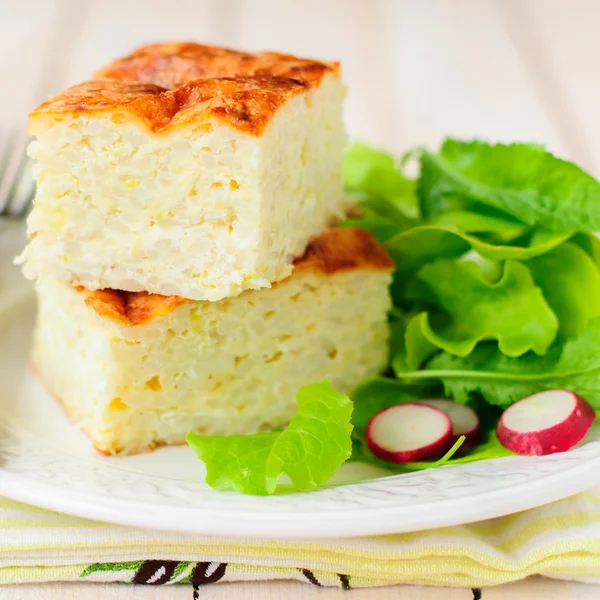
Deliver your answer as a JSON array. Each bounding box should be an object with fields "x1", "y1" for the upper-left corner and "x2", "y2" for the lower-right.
[{"x1": 31, "y1": 43, "x2": 339, "y2": 136}]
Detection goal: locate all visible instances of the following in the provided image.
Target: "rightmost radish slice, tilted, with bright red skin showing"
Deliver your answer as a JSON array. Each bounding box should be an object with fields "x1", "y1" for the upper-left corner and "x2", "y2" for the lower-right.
[{"x1": 496, "y1": 390, "x2": 596, "y2": 456}]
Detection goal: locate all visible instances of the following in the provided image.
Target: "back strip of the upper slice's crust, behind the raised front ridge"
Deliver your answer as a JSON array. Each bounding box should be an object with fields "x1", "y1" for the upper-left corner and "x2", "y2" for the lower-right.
[{"x1": 94, "y1": 42, "x2": 340, "y2": 89}]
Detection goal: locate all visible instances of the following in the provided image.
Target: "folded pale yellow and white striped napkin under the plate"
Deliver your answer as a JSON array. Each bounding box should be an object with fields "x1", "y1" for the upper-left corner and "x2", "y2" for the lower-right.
[{"x1": 0, "y1": 488, "x2": 600, "y2": 589}]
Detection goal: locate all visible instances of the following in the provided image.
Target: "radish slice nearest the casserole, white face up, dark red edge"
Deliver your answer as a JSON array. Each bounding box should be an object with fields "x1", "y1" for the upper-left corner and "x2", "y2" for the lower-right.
[{"x1": 365, "y1": 402, "x2": 452, "y2": 463}]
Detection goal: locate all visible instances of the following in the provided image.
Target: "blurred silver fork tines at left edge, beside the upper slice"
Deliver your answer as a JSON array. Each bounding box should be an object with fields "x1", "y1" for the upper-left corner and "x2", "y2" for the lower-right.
[{"x1": 0, "y1": 130, "x2": 35, "y2": 230}]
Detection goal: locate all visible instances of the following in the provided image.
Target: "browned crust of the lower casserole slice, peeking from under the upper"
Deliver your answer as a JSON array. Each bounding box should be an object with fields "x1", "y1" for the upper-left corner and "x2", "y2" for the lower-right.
[{"x1": 75, "y1": 227, "x2": 394, "y2": 326}]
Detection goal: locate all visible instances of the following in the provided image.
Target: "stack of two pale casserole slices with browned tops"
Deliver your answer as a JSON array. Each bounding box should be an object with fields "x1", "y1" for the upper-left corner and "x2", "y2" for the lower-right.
[{"x1": 20, "y1": 43, "x2": 392, "y2": 454}]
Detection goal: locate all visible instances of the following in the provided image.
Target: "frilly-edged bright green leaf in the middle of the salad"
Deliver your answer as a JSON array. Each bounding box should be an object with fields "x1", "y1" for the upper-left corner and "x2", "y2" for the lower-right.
[{"x1": 398, "y1": 259, "x2": 558, "y2": 369}]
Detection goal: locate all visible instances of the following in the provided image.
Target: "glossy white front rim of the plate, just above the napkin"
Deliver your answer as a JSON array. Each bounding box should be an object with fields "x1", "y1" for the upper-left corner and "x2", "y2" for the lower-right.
[{"x1": 0, "y1": 441, "x2": 600, "y2": 539}]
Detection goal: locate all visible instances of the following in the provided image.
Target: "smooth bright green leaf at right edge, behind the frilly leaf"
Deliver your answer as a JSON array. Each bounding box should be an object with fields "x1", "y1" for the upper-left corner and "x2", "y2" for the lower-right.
[{"x1": 527, "y1": 242, "x2": 600, "y2": 337}]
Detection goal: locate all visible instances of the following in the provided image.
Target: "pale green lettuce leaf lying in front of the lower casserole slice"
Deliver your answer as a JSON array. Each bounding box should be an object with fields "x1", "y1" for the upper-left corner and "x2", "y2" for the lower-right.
[{"x1": 187, "y1": 380, "x2": 352, "y2": 495}]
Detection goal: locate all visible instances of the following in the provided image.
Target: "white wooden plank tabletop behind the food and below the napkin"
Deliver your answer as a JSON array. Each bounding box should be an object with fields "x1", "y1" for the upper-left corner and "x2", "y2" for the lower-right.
[{"x1": 0, "y1": 0, "x2": 600, "y2": 600}]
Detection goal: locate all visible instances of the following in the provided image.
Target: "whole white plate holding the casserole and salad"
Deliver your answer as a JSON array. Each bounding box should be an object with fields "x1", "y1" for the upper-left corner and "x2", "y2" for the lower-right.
[{"x1": 0, "y1": 296, "x2": 600, "y2": 538}]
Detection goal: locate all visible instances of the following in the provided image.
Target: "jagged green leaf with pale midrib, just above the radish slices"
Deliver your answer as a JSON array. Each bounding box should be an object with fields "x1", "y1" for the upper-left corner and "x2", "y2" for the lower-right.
[{"x1": 396, "y1": 318, "x2": 600, "y2": 409}]
